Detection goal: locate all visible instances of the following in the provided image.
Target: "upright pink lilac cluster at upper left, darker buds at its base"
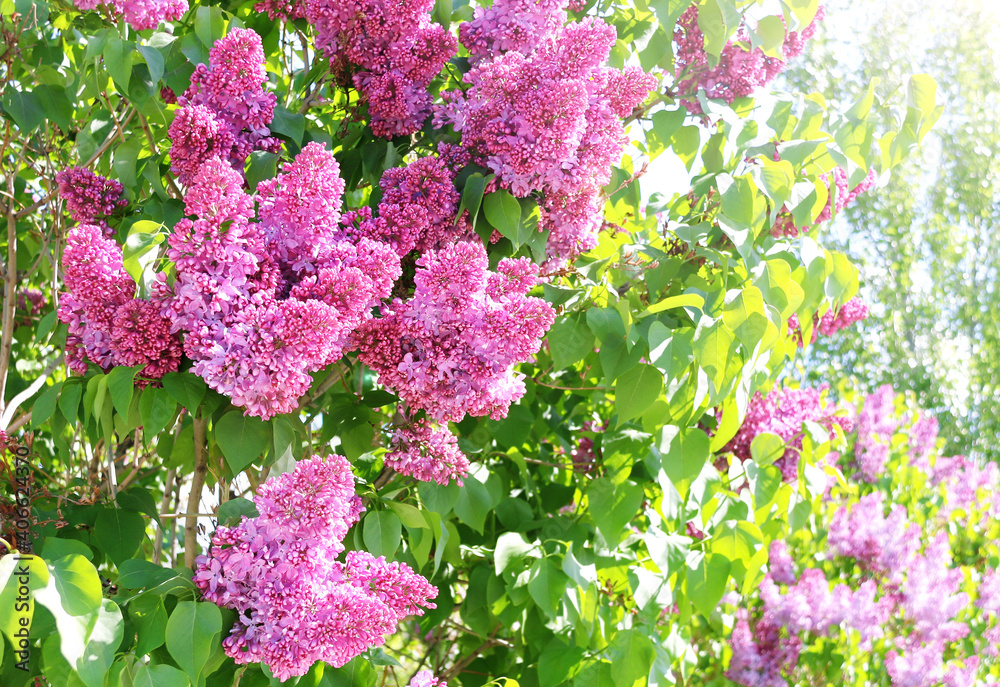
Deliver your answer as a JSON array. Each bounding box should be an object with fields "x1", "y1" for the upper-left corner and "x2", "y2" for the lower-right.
[{"x1": 168, "y1": 29, "x2": 281, "y2": 184}]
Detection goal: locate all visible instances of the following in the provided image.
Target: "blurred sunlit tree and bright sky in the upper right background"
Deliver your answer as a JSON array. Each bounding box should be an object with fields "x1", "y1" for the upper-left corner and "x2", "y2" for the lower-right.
[{"x1": 783, "y1": 0, "x2": 1000, "y2": 461}]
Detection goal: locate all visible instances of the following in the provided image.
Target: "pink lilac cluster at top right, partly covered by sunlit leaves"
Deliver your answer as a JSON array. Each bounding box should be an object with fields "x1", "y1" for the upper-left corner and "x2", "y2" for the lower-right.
[{"x1": 674, "y1": 4, "x2": 823, "y2": 114}]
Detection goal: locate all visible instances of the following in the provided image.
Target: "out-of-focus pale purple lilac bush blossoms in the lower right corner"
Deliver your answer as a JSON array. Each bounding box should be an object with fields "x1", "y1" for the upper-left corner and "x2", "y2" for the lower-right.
[{"x1": 727, "y1": 387, "x2": 1000, "y2": 687}]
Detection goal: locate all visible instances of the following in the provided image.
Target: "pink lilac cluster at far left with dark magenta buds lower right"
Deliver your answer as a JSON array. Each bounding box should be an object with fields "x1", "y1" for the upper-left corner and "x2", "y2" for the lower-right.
[{"x1": 58, "y1": 224, "x2": 181, "y2": 386}]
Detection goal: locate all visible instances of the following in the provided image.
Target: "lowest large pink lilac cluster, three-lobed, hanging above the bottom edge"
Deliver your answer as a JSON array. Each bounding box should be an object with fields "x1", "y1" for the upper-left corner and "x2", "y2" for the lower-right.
[{"x1": 194, "y1": 455, "x2": 437, "y2": 680}]
